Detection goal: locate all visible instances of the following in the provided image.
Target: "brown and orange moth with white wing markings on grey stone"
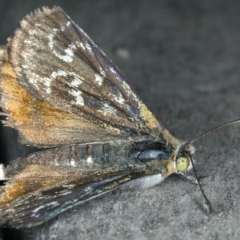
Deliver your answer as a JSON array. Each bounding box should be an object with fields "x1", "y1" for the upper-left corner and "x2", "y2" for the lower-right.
[{"x1": 0, "y1": 7, "x2": 214, "y2": 228}]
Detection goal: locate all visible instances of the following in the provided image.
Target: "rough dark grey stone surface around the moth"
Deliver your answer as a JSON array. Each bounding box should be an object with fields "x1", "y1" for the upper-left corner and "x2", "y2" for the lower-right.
[{"x1": 0, "y1": 0, "x2": 240, "y2": 240}]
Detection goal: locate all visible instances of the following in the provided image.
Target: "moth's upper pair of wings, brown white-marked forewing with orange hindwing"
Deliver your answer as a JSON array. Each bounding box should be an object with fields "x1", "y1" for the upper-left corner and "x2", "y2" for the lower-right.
[{"x1": 0, "y1": 7, "x2": 162, "y2": 146}]
